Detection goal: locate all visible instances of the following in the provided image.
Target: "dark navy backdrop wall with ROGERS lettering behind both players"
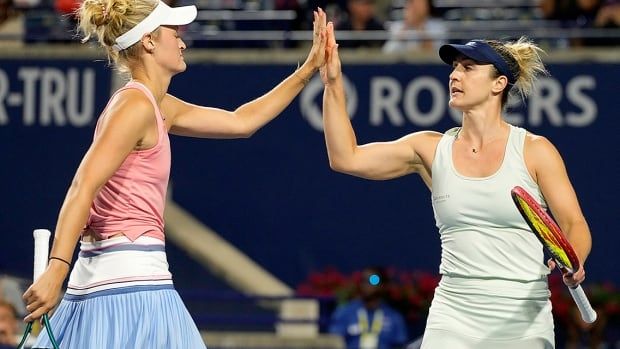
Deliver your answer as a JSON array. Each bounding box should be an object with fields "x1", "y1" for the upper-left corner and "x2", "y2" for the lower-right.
[{"x1": 0, "y1": 62, "x2": 620, "y2": 286}]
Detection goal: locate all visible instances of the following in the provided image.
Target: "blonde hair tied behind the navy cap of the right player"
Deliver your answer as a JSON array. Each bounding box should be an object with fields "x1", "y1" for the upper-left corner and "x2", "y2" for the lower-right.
[{"x1": 485, "y1": 36, "x2": 548, "y2": 105}]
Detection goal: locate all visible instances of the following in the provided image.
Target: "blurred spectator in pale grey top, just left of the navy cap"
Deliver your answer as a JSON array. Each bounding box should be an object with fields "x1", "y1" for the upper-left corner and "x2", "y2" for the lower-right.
[{"x1": 383, "y1": 0, "x2": 446, "y2": 53}]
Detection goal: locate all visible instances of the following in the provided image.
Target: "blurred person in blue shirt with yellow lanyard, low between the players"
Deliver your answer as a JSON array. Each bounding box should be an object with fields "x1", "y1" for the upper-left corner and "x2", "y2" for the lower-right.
[{"x1": 329, "y1": 268, "x2": 408, "y2": 349}]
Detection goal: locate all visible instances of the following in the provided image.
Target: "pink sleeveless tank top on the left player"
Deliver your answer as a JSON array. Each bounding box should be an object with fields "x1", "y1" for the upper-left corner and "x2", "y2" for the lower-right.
[{"x1": 85, "y1": 81, "x2": 171, "y2": 241}]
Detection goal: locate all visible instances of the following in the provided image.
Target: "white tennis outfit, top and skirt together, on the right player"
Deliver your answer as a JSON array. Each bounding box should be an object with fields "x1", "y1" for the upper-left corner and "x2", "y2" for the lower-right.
[{"x1": 422, "y1": 126, "x2": 555, "y2": 349}]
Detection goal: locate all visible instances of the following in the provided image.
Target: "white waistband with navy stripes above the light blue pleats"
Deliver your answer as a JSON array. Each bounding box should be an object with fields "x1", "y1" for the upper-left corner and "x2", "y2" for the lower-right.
[{"x1": 65, "y1": 236, "x2": 172, "y2": 300}]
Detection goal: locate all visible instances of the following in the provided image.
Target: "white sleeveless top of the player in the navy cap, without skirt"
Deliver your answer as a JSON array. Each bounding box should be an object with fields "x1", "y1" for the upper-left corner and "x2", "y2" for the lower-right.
[{"x1": 432, "y1": 126, "x2": 549, "y2": 282}]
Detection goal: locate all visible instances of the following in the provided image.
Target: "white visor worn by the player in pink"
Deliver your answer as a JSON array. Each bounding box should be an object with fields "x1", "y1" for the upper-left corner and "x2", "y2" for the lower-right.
[{"x1": 112, "y1": 1, "x2": 198, "y2": 51}]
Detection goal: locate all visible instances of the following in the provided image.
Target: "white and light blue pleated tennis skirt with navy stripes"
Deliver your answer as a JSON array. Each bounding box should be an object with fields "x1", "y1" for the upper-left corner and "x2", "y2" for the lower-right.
[{"x1": 34, "y1": 236, "x2": 206, "y2": 349}]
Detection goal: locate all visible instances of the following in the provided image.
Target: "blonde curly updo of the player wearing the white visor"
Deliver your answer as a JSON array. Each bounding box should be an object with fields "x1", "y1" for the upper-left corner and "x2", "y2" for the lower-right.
[{"x1": 77, "y1": 0, "x2": 158, "y2": 72}]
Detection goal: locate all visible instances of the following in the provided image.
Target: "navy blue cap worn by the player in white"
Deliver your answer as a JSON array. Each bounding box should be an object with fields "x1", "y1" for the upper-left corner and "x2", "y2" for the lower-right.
[{"x1": 439, "y1": 40, "x2": 517, "y2": 85}]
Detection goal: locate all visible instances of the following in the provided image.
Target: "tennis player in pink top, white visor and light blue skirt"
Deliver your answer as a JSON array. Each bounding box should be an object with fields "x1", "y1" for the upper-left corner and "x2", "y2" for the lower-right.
[{"x1": 24, "y1": 0, "x2": 334, "y2": 349}]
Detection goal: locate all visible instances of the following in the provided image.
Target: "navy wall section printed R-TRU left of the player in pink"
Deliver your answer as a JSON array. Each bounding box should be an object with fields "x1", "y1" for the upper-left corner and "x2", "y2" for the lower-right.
[{"x1": 0, "y1": 60, "x2": 111, "y2": 278}]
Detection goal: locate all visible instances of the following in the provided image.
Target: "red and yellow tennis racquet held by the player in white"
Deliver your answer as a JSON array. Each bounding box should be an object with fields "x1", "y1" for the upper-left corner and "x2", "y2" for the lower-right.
[{"x1": 510, "y1": 186, "x2": 596, "y2": 323}]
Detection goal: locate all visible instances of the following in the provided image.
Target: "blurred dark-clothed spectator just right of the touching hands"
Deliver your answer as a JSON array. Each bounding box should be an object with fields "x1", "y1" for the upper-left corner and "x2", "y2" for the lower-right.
[{"x1": 336, "y1": 0, "x2": 385, "y2": 47}]
